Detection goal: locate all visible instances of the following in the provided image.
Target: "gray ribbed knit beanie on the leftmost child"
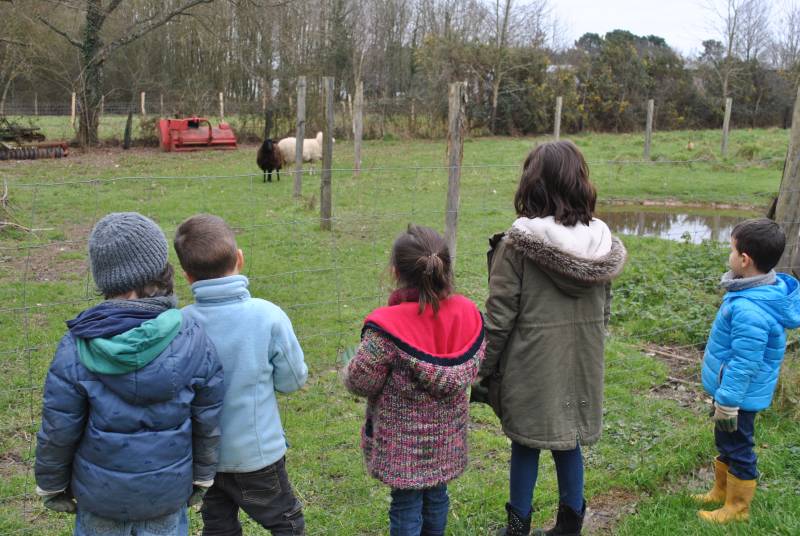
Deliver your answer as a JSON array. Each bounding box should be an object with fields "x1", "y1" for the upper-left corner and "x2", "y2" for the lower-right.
[{"x1": 89, "y1": 212, "x2": 168, "y2": 296}]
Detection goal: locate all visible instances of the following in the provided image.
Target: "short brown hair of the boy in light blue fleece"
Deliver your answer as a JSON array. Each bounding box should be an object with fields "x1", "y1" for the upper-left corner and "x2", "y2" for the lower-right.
[{"x1": 174, "y1": 214, "x2": 238, "y2": 281}]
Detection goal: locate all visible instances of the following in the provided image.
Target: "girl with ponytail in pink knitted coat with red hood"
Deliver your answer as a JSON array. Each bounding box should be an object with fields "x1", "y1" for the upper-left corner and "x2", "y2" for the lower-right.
[{"x1": 344, "y1": 225, "x2": 483, "y2": 536}]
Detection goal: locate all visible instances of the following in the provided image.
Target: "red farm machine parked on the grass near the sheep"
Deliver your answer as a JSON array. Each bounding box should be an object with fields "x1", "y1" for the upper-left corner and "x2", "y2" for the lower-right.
[{"x1": 158, "y1": 117, "x2": 236, "y2": 152}]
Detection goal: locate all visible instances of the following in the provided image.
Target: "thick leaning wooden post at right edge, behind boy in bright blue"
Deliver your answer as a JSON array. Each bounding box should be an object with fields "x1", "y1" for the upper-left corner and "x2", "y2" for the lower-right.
[{"x1": 775, "y1": 88, "x2": 800, "y2": 273}]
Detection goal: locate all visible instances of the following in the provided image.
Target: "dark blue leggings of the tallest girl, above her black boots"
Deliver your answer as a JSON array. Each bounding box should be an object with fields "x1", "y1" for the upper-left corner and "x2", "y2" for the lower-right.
[{"x1": 508, "y1": 442, "x2": 583, "y2": 517}]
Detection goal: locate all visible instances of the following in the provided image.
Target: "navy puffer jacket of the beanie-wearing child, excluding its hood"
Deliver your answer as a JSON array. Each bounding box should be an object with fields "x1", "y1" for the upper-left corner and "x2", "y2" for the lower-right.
[{"x1": 35, "y1": 310, "x2": 224, "y2": 520}]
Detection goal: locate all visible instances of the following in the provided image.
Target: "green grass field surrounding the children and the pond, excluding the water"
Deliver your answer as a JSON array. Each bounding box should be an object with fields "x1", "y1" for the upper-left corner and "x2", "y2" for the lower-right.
[{"x1": 0, "y1": 130, "x2": 800, "y2": 535}]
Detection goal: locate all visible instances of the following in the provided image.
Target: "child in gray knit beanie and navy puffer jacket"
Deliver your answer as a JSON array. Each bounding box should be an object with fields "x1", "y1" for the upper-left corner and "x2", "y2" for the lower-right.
[{"x1": 35, "y1": 212, "x2": 223, "y2": 536}]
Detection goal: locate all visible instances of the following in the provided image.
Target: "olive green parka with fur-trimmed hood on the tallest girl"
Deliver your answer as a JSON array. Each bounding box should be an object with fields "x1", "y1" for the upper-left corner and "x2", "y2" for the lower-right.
[{"x1": 480, "y1": 220, "x2": 627, "y2": 450}]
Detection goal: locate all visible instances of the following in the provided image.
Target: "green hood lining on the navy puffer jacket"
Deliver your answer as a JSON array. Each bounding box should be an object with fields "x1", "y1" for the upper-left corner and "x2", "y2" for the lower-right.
[{"x1": 75, "y1": 309, "x2": 183, "y2": 375}]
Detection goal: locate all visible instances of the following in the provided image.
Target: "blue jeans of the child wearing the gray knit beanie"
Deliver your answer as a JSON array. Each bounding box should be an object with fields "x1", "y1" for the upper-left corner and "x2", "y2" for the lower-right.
[{"x1": 74, "y1": 508, "x2": 189, "y2": 536}]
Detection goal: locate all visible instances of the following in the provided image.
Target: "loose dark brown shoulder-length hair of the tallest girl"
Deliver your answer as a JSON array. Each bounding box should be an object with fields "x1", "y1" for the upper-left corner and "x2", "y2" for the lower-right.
[{"x1": 514, "y1": 140, "x2": 597, "y2": 227}]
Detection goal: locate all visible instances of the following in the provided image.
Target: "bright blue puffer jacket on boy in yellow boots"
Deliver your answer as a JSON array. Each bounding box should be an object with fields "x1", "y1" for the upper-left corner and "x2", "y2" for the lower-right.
[{"x1": 703, "y1": 274, "x2": 800, "y2": 411}]
